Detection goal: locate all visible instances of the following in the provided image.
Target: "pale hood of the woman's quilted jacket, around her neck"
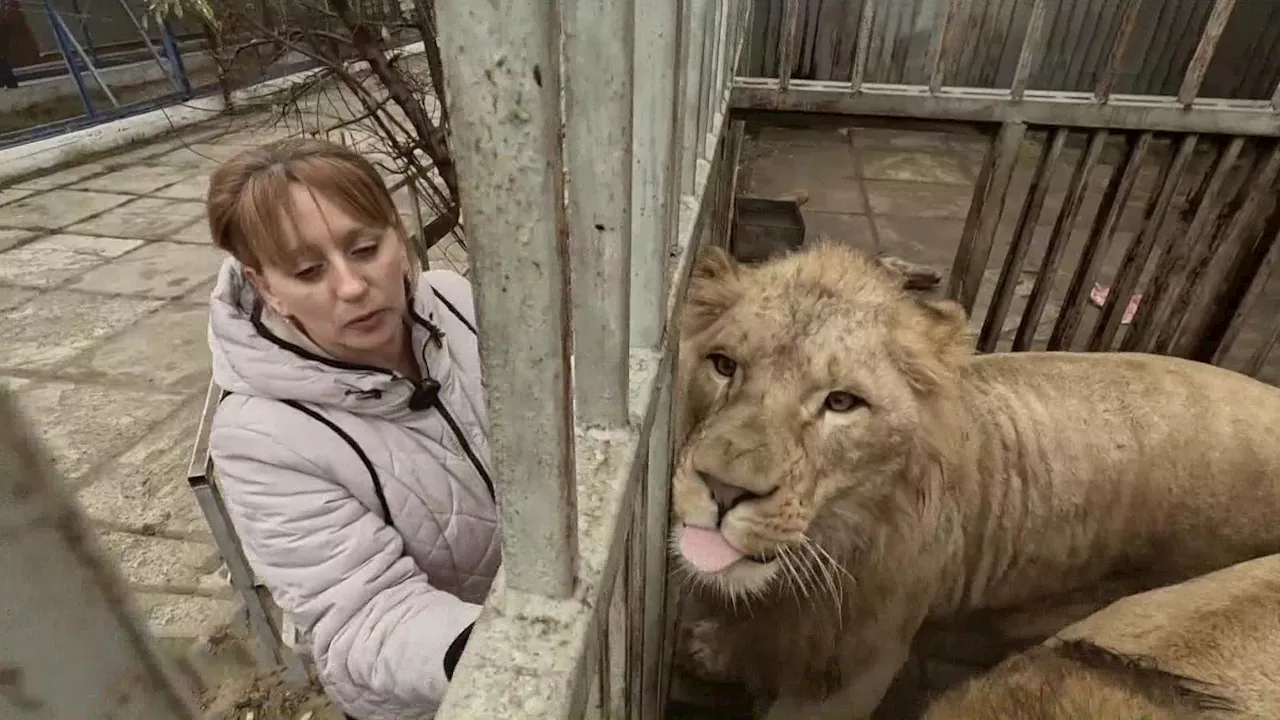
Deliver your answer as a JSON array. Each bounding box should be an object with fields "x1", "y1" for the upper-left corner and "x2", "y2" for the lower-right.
[{"x1": 209, "y1": 258, "x2": 451, "y2": 416}]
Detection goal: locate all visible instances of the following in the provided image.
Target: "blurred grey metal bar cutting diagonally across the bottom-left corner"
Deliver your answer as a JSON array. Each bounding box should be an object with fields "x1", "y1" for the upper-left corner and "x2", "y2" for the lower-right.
[{"x1": 0, "y1": 388, "x2": 200, "y2": 720}]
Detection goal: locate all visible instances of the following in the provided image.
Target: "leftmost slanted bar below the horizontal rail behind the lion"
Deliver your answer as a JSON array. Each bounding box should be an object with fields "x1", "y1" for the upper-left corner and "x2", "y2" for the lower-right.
[{"x1": 951, "y1": 123, "x2": 1027, "y2": 313}]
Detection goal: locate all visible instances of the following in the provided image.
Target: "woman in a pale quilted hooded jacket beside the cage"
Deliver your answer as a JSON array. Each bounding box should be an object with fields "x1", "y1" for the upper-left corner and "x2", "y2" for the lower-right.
[{"x1": 207, "y1": 140, "x2": 500, "y2": 720}]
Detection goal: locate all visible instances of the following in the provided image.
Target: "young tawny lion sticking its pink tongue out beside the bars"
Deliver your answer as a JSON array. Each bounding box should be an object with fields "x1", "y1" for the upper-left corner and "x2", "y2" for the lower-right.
[{"x1": 669, "y1": 242, "x2": 1280, "y2": 720}]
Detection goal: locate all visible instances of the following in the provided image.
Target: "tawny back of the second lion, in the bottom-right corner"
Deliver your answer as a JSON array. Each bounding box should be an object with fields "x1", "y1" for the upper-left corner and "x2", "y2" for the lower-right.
[{"x1": 924, "y1": 555, "x2": 1280, "y2": 720}]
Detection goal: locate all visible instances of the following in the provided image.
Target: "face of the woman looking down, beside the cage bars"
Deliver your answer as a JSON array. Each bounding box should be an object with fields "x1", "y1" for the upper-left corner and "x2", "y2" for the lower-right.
[{"x1": 251, "y1": 184, "x2": 410, "y2": 366}]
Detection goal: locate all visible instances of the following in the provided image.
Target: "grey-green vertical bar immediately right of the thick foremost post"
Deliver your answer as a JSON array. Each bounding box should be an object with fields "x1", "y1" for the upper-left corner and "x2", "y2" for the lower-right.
[{"x1": 561, "y1": 0, "x2": 635, "y2": 427}]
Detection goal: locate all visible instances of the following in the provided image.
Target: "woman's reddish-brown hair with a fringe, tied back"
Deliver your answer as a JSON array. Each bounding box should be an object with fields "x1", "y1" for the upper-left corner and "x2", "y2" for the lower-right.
[{"x1": 205, "y1": 138, "x2": 415, "y2": 270}]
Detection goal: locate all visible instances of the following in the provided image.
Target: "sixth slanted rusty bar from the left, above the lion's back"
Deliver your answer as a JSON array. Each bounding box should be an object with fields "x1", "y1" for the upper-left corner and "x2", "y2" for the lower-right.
[{"x1": 1136, "y1": 137, "x2": 1244, "y2": 352}]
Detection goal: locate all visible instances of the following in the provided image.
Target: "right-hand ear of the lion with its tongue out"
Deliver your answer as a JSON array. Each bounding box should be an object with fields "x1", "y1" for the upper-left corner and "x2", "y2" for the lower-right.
[{"x1": 897, "y1": 296, "x2": 973, "y2": 392}]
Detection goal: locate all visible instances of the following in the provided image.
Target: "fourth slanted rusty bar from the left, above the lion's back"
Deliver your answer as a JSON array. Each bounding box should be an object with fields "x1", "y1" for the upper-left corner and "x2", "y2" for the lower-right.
[{"x1": 1048, "y1": 132, "x2": 1153, "y2": 350}]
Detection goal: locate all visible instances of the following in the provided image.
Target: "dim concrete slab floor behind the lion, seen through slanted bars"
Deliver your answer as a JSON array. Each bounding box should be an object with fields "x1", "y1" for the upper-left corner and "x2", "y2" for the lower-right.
[{"x1": 739, "y1": 127, "x2": 1280, "y2": 383}]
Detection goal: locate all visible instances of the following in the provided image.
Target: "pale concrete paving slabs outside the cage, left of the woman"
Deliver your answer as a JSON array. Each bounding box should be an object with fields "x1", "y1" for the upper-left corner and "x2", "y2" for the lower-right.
[{"x1": 0, "y1": 119, "x2": 259, "y2": 661}]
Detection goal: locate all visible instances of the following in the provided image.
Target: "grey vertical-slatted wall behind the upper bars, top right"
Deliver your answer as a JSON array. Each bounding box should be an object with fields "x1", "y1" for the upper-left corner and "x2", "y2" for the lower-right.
[{"x1": 742, "y1": 0, "x2": 1280, "y2": 100}]
